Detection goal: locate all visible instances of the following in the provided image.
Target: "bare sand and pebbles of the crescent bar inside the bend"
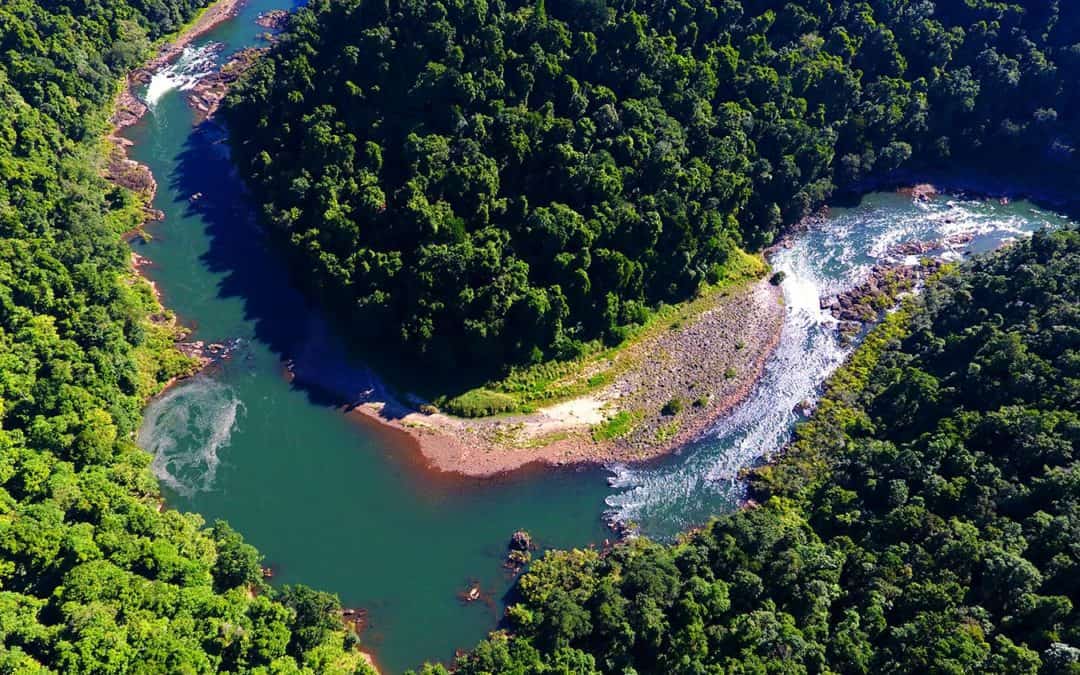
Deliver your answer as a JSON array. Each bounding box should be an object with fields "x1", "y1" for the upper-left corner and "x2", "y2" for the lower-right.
[{"x1": 336, "y1": 280, "x2": 785, "y2": 478}]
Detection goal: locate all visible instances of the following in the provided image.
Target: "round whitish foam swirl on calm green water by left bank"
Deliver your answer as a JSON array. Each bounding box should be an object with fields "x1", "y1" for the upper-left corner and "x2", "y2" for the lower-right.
[{"x1": 138, "y1": 376, "x2": 244, "y2": 497}]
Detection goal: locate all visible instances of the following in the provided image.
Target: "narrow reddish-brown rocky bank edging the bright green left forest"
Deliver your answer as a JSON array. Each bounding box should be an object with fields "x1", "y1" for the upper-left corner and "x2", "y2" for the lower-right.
[{"x1": 103, "y1": 0, "x2": 382, "y2": 674}]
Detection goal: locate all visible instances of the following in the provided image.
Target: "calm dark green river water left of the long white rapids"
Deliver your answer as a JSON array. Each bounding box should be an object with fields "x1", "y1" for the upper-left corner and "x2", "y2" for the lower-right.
[{"x1": 127, "y1": 0, "x2": 610, "y2": 673}]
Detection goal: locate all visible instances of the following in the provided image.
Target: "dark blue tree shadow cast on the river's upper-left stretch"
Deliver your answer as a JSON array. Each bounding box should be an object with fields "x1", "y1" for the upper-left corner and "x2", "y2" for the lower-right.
[{"x1": 172, "y1": 122, "x2": 405, "y2": 418}]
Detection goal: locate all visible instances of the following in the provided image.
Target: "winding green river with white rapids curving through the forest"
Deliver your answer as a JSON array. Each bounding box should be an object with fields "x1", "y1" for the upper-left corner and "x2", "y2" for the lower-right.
[{"x1": 125, "y1": 0, "x2": 1071, "y2": 673}]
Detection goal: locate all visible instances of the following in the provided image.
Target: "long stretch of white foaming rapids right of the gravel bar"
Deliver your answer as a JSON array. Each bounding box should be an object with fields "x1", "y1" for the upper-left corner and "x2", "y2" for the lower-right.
[{"x1": 606, "y1": 191, "x2": 1061, "y2": 538}]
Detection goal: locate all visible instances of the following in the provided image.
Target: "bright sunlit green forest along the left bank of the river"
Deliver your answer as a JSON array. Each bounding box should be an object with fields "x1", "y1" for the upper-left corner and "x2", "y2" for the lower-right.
[{"x1": 0, "y1": 0, "x2": 366, "y2": 673}]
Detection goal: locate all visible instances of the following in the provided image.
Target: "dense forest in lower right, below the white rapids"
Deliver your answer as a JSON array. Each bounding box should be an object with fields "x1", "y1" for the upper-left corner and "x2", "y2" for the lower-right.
[{"x1": 416, "y1": 230, "x2": 1080, "y2": 675}]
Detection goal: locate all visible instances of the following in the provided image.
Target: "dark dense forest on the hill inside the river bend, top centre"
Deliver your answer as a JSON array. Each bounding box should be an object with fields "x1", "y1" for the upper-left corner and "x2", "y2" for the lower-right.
[{"x1": 226, "y1": 0, "x2": 1080, "y2": 368}]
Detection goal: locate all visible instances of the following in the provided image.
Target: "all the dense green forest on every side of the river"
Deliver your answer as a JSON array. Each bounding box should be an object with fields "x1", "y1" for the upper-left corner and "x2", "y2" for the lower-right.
[{"x1": 0, "y1": 0, "x2": 1080, "y2": 675}]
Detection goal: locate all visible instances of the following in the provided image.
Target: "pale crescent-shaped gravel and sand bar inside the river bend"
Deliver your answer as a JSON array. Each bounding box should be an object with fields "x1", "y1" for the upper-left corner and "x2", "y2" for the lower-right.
[{"x1": 336, "y1": 280, "x2": 784, "y2": 476}]
